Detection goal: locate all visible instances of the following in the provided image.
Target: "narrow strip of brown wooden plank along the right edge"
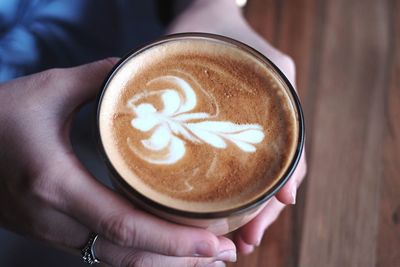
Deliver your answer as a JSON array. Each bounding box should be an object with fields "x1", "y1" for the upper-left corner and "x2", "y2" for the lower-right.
[{"x1": 376, "y1": 1, "x2": 400, "y2": 267}]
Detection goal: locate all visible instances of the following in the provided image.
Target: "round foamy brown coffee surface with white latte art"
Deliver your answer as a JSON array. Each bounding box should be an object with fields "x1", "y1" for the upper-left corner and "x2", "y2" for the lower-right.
[{"x1": 99, "y1": 38, "x2": 298, "y2": 212}]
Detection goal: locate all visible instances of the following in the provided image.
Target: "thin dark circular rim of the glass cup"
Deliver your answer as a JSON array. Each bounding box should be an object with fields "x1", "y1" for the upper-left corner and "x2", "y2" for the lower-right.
[{"x1": 95, "y1": 32, "x2": 305, "y2": 219}]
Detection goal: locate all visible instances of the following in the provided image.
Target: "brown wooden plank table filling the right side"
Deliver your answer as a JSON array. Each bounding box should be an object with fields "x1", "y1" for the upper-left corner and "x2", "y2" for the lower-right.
[{"x1": 230, "y1": 0, "x2": 400, "y2": 267}]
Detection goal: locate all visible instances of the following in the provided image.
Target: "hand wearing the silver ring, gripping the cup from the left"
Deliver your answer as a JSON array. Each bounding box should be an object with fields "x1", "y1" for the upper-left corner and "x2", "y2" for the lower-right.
[{"x1": 0, "y1": 59, "x2": 236, "y2": 267}]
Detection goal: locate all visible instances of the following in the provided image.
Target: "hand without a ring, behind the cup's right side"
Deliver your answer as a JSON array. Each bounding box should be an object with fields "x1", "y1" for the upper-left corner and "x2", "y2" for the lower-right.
[{"x1": 169, "y1": 0, "x2": 307, "y2": 254}]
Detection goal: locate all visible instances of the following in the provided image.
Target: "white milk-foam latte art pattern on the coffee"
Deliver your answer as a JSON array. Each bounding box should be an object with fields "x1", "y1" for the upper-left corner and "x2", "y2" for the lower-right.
[{"x1": 127, "y1": 75, "x2": 264, "y2": 164}]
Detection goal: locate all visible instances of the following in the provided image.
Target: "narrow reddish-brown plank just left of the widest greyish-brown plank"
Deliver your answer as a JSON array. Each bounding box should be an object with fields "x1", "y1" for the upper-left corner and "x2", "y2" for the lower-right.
[{"x1": 271, "y1": 0, "x2": 323, "y2": 266}]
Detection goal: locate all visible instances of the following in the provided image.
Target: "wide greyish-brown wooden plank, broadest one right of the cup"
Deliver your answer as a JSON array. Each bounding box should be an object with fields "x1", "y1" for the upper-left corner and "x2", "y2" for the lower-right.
[{"x1": 299, "y1": 0, "x2": 389, "y2": 267}]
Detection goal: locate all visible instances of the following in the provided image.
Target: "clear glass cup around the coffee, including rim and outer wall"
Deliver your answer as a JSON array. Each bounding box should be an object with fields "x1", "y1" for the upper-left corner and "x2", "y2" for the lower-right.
[{"x1": 96, "y1": 33, "x2": 305, "y2": 235}]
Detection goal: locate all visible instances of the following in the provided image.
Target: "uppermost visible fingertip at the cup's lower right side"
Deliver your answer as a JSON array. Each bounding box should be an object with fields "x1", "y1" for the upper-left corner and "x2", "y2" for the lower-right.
[{"x1": 276, "y1": 151, "x2": 307, "y2": 205}]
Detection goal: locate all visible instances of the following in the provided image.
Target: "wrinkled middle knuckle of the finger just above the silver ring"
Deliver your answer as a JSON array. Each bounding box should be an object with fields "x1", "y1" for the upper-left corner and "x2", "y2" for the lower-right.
[{"x1": 100, "y1": 215, "x2": 137, "y2": 247}]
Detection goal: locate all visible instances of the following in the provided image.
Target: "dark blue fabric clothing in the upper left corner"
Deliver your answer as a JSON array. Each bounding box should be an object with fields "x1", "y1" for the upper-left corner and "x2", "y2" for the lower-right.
[{"x1": 0, "y1": 0, "x2": 163, "y2": 82}]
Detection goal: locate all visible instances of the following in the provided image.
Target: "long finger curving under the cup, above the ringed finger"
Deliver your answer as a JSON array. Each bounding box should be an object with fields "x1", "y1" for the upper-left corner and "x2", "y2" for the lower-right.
[{"x1": 51, "y1": 155, "x2": 230, "y2": 256}]
